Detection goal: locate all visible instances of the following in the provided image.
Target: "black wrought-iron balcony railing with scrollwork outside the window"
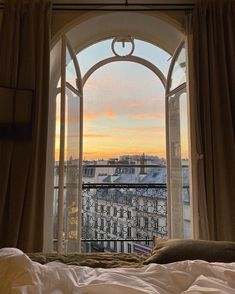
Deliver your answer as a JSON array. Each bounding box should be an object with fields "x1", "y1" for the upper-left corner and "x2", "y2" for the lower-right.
[{"x1": 54, "y1": 163, "x2": 189, "y2": 253}]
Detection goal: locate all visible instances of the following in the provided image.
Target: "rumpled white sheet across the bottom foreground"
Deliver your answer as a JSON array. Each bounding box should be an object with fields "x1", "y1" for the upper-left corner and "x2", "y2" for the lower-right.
[{"x1": 0, "y1": 248, "x2": 235, "y2": 294}]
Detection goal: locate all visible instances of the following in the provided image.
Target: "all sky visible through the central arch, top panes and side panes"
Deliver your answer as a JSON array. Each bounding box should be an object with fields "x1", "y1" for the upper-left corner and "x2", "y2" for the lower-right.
[{"x1": 54, "y1": 40, "x2": 187, "y2": 160}]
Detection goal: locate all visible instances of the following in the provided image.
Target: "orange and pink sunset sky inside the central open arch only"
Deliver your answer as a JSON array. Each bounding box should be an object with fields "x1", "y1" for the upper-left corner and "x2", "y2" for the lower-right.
[{"x1": 81, "y1": 62, "x2": 165, "y2": 159}]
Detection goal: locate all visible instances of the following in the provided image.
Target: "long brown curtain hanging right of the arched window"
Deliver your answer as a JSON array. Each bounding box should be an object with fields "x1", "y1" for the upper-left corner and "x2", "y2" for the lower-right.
[{"x1": 189, "y1": 0, "x2": 235, "y2": 241}]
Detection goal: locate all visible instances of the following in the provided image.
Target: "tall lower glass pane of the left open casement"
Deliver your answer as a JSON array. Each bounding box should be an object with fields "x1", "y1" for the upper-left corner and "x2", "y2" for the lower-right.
[{"x1": 63, "y1": 88, "x2": 80, "y2": 252}]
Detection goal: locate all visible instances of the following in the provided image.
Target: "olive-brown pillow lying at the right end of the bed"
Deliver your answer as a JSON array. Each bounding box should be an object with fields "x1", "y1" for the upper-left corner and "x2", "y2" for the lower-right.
[{"x1": 144, "y1": 239, "x2": 235, "y2": 264}]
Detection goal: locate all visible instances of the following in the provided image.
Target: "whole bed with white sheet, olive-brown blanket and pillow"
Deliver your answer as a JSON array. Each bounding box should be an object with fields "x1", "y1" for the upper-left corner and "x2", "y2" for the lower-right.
[{"x1": 0, "y1": 240, "x2": 235, "y2": 294}]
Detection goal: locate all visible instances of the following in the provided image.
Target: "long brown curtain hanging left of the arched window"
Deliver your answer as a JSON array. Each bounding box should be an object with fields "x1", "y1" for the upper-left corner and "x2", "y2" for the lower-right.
[{"x1": 0, "y1": 0, "x2": 51, "y2": 252}]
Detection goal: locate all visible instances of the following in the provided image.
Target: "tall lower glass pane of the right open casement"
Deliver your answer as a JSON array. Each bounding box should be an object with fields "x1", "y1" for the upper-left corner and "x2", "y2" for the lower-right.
[{"x1": 168, "y1": 89, "x2": 191, "y2": 238}]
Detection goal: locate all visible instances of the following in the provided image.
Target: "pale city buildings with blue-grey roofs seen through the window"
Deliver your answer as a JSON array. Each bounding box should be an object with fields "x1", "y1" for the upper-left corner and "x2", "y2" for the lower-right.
[{"x1": 54, "y1": 155, "x2": 191, "y2": 253}]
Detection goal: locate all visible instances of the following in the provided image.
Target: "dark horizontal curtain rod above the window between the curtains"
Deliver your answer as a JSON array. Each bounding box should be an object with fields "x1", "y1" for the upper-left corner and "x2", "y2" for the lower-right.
[{"x1": 0, "y1": 0, "x2": 194, "y2": 11}]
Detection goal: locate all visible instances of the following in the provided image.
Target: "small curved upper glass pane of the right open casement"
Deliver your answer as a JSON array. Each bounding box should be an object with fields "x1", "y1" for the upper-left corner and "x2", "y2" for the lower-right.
[{"x1": 170, "y1": 47, "x2": 186, "y2": 91}]
